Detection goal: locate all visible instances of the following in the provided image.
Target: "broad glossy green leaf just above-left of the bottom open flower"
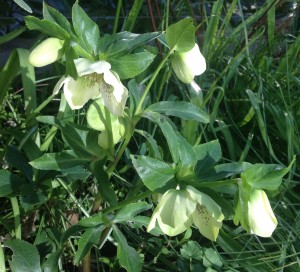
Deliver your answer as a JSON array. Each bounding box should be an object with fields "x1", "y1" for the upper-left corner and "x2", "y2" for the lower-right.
[{"x1": 131, "y1": 156, "x2": 176, "y2": 192}]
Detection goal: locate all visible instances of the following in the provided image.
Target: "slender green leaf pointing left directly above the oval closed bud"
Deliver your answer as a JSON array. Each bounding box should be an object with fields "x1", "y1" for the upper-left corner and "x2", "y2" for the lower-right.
[{"x1": 24, "y1": 16, "x2": 70, "y2": 40}]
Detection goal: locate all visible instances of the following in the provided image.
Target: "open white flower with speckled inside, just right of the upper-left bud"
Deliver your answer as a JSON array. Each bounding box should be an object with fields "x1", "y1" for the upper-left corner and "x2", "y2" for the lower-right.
[{"x1": 54, "y1": 58, "x2": 128, "y2": 116}]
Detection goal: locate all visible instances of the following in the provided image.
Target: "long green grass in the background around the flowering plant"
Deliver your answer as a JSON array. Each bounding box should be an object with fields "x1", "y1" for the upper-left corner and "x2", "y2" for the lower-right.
[{"x1": 0, "y1": 0, "x2": 300, "y2": 272}]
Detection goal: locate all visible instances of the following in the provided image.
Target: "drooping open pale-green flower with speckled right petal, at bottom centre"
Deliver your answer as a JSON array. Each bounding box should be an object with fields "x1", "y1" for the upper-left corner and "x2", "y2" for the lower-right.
[{"x1": 147, "y1": 186, "x2": 224, "y2": 241}]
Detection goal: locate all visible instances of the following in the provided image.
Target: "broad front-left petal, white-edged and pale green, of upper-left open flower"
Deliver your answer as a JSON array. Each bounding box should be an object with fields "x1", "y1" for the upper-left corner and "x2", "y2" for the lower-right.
[{"x1": 64, "y1": 77, "x2": 99, "y2": 110}]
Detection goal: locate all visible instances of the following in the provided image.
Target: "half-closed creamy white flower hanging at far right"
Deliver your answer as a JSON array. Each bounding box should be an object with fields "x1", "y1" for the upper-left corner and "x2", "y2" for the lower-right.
[{"x1": 248, "y1": 189, "x2": 277, "y2": 237}]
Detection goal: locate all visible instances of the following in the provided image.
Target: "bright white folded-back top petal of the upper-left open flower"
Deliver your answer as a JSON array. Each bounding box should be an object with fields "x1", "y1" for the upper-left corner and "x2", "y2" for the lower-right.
[{"x1": 74, "y1": 58, "x2": 111, "y2": 76}]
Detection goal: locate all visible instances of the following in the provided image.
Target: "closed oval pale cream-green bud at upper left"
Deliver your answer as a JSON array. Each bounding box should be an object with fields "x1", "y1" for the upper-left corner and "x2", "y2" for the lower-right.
[{"x1": 29, "y1": 38, "x2": 64, "y2": 67}]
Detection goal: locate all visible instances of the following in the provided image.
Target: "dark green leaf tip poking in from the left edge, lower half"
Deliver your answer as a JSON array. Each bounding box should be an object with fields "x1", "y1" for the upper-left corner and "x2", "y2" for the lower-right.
[{"x1": 0, "y1": 169, "x2": 23, "y2": 197}]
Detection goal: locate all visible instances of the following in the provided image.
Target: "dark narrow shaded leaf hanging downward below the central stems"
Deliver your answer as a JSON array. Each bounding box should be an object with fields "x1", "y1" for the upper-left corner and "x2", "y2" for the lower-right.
[{"x1": 90, "y1": 160, "x2": 118, "y2": 206}]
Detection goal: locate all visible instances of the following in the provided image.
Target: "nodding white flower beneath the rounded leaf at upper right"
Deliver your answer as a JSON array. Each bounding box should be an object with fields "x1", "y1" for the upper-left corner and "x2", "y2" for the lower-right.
[{"x1": 171, "y1": 44, "x2": 206, "y2": 91}]
